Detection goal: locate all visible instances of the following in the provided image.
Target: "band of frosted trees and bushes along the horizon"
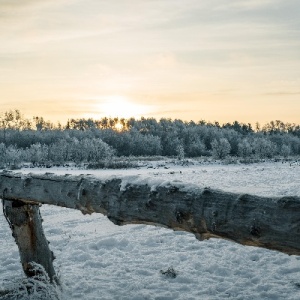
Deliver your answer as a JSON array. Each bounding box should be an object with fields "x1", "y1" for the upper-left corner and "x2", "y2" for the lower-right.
[{"x1": 0, "y1": 110, "x2": 300, "y2": 168}]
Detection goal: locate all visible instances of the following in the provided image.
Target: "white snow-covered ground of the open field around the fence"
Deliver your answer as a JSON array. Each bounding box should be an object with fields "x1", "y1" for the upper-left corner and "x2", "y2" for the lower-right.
[{"x1": 0, "y1": 162, "x2": 300, "y2": 300}]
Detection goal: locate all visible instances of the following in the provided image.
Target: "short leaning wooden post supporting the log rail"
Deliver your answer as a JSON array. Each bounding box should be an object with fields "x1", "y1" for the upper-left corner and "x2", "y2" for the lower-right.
[{"x1": 3, "y1": 199, "x2": 58, "y2": 283}]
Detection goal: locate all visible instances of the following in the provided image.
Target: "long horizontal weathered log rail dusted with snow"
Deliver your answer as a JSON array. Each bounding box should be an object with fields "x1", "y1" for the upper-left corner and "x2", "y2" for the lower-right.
[{"x1": 0, "y1": 172, "x2": 300, "y2": 255}]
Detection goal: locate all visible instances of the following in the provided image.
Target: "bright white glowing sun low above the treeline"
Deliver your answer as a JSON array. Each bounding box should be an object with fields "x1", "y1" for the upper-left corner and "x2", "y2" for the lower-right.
[{"x1": 99, "y1": 96, "x2": 149, "y2": 119}]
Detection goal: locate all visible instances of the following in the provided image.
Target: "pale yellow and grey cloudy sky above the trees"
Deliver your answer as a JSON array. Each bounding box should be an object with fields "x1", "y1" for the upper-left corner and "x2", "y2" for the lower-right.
[{"x1": 0, "y1": 0, "x2": 300, "y2": 124}]
